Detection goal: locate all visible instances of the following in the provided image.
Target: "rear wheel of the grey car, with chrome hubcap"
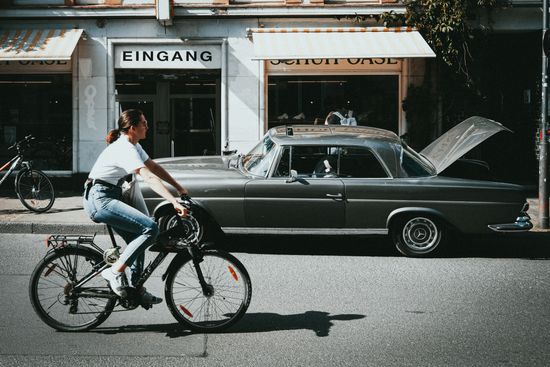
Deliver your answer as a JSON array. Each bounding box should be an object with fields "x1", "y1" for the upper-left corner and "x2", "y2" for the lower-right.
[{"x1": 391, "y1": 215, "x2": 446, "y2": 257}]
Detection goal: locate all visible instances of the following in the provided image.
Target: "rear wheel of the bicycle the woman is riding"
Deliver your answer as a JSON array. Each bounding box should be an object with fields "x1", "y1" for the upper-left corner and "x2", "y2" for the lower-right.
[{"x1": 29, "y1": 247, "x2": 116, "y2": 331}]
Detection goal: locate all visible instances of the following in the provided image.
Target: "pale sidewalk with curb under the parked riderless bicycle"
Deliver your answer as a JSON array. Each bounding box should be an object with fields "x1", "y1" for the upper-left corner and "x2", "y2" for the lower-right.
[{"x1": 0, "y1": 191, "x2": 550, "y2": 234}]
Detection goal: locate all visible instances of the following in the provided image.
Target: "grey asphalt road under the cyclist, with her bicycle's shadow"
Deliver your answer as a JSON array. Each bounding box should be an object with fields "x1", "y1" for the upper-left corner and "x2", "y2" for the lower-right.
[{"x1": 0, "y1": 234, "x2": 550, "y2": 367}]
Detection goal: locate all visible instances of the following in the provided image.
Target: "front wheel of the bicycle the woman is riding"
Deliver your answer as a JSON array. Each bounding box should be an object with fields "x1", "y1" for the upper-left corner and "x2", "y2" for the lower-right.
[{"x1": 165, "y1": 250, "x2": 252, "y2": 332}]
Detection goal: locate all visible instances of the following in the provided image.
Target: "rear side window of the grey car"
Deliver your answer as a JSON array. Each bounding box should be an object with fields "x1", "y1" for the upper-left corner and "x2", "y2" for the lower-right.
[{"x1": 339, "y1": 147, "x2": 388, "y2": 178}]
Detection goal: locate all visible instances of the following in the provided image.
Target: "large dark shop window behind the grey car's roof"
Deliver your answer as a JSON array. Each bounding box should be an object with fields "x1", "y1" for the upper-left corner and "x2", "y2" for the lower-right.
[{"x1": 268, "y1": 75, "x2": 399, "y2": 133}]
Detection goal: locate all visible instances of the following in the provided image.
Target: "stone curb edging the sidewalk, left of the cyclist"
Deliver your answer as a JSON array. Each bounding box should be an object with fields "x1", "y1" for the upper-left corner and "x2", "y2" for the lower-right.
[{"x1": 0, "y1": 222, "x2": 108, "y2": 235}]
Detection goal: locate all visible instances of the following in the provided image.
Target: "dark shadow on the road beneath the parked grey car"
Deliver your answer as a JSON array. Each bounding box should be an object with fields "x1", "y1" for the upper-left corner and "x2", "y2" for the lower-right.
[{"x1": 224, "y1": 232, "x2": 550, "y2": 259}]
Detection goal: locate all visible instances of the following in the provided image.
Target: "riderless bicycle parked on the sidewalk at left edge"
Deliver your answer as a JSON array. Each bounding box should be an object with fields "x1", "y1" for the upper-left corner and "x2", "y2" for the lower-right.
[{"x1": 0, "y1": 135, "x2": 55, "y2": 213}]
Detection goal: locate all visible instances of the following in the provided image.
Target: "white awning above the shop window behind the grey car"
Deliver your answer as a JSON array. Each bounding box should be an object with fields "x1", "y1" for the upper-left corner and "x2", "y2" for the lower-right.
[{"x1": 247, "y1": 27, "x2": 435, "y2": 60}]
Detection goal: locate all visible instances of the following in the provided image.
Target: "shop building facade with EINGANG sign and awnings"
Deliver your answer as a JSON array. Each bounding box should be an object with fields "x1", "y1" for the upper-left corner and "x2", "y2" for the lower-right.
[{"x1": 0, "y1": 0, "x2": 544, "y2": 184}]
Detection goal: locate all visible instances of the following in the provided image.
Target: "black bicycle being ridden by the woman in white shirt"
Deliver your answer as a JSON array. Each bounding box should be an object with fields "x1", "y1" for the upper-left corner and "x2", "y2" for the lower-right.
[{"x1": 29, "y1": 197, "x2": 252, "y2": 332}]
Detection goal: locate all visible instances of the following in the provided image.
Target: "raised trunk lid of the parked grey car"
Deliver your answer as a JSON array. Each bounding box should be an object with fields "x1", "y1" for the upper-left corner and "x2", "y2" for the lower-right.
[{"x1": 420, "y1": 116, "x2": 512, "y2": 174}]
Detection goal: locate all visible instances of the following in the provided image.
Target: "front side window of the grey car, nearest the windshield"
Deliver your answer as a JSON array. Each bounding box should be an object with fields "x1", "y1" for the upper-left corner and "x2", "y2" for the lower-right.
[{"x1": 273, "y1": 145, "x2": 338, "y2": 178}]
